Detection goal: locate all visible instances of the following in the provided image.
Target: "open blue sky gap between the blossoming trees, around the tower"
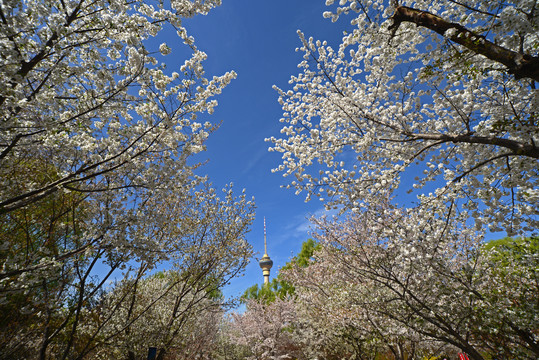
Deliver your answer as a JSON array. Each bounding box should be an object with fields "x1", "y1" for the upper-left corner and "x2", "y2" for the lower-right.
[{"x1": 158, "y1": 0, "x2": 349, "y2": 296}]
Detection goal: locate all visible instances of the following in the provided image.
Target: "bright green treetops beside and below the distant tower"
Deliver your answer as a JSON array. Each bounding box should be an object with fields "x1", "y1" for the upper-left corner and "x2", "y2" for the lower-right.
[{"x1": 240, "y1": 239, "x2": 320, "y2": 304}]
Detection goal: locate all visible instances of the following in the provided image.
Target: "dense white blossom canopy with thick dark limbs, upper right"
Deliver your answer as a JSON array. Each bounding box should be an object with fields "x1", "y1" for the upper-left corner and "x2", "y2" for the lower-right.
[{"x1": 268, "y1": 0, "x2": 539, "y2": 234}]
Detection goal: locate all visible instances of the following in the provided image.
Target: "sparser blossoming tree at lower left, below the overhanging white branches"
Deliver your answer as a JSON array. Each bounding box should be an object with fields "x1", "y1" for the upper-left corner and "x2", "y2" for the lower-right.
[{"x1": 1, "y1": 184, "x2": 254, "y2": 359}]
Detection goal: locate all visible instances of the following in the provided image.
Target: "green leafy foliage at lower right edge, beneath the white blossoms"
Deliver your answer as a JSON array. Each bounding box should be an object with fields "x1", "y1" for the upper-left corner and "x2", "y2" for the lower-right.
[{"x1": 476, "y1": 237, "x2": 539, "y2": 359}]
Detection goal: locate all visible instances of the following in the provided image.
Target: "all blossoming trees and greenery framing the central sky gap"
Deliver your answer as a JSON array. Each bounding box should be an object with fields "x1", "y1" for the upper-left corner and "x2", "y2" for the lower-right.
[{"x1": 0, "y1": 0, "x2": 539, "y2": 360}]
